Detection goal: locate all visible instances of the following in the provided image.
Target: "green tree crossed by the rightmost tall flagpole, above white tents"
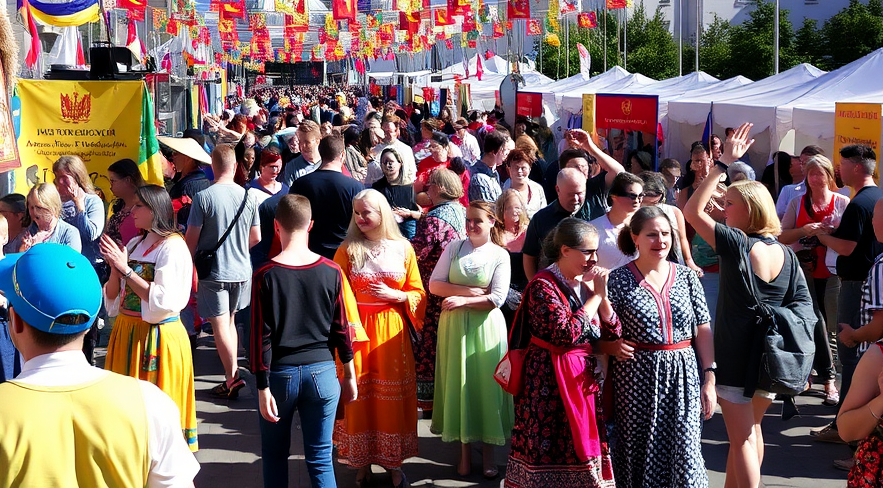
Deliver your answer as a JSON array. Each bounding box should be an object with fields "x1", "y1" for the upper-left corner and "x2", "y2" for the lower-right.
[{"x1": 727, "y1": 0, "x2": 797, "y2": 80}]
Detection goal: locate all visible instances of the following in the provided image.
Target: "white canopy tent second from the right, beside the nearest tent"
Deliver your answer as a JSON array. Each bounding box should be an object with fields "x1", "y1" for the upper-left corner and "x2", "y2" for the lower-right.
[{"x1": 665, "y1": 64, "x2": 825, "y2": 166}]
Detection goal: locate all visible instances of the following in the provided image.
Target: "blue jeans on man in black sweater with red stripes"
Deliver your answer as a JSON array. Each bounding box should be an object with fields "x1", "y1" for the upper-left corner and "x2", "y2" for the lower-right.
[{"x1": 259, "y1": 361, "x2": 340, "y2": 488}]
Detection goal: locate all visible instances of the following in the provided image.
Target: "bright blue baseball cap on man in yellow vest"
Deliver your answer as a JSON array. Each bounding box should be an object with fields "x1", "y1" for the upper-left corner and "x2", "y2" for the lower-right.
[{"x1": 0, "y1": 243, "x2": 102, "y2": 334}]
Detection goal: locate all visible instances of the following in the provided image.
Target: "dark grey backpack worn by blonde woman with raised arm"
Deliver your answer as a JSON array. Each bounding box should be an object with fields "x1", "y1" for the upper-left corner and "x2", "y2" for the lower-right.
[{"x1": 745, "y1": 241, "x2": 816, "y2": 396}]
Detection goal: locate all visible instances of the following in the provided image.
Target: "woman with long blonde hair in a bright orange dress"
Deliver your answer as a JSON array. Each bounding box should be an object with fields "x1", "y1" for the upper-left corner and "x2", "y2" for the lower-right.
[{"x1": 334, "y1": 190, "x2": 426, "y2": 487}]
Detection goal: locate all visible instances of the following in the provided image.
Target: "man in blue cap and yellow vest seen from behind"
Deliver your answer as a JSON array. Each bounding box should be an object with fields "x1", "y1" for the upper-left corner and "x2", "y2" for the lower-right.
[{"x1": 0, "y1": 244, "x2": 199, "y2": 488}]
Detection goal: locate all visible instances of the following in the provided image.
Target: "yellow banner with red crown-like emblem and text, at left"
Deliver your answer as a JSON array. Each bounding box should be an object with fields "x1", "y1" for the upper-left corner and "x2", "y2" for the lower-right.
[{"x1": 15, "y1": 80, "x2": 142, "y2": 198}]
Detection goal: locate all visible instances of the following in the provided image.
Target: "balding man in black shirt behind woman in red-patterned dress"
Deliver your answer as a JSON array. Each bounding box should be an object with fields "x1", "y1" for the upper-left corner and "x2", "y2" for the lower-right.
[{"x1": 521, "y1": 168, "x2": 586, "y2": 280}]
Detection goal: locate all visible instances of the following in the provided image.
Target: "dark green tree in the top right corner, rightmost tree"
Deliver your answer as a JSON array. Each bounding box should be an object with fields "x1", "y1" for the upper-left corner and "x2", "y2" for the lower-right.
[{"x1": 822, "y1": 0, "x2": 883, "y2": 69}]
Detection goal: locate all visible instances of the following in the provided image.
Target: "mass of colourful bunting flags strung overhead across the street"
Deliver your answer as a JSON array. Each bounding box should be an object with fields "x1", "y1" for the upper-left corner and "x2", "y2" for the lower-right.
[{"x1": 17, "y1": 0, "x2": 632, "y2": 72}]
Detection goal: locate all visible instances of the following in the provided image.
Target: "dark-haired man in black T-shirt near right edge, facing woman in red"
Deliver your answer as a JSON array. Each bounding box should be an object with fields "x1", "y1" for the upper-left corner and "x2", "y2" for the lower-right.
[{"x1": 813, "y1": 144, "x2": 883, "y2": 442}]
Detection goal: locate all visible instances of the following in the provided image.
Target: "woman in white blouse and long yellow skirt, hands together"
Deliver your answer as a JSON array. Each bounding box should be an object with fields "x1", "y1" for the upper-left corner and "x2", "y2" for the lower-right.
[{"x1": 101, "y1": 185, "x2": 198, "y2": 451}]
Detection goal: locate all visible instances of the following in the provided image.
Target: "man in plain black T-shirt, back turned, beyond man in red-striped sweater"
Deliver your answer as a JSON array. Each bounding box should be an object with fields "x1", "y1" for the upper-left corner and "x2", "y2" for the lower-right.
[{"x1": 289, "y1": 135, "x2": 364, "y2": 259}]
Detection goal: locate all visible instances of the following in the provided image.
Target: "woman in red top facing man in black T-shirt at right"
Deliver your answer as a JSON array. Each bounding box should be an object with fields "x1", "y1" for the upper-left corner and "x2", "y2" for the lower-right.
[{"x1": 779, "y1": 155, "x2": 849, "y2": 406}]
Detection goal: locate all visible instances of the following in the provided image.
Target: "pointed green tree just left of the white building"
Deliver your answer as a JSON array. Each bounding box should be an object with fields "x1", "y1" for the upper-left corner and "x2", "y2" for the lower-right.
[{"x1": 626, "y1": 2, "x2": 678, "y2": 80}]
